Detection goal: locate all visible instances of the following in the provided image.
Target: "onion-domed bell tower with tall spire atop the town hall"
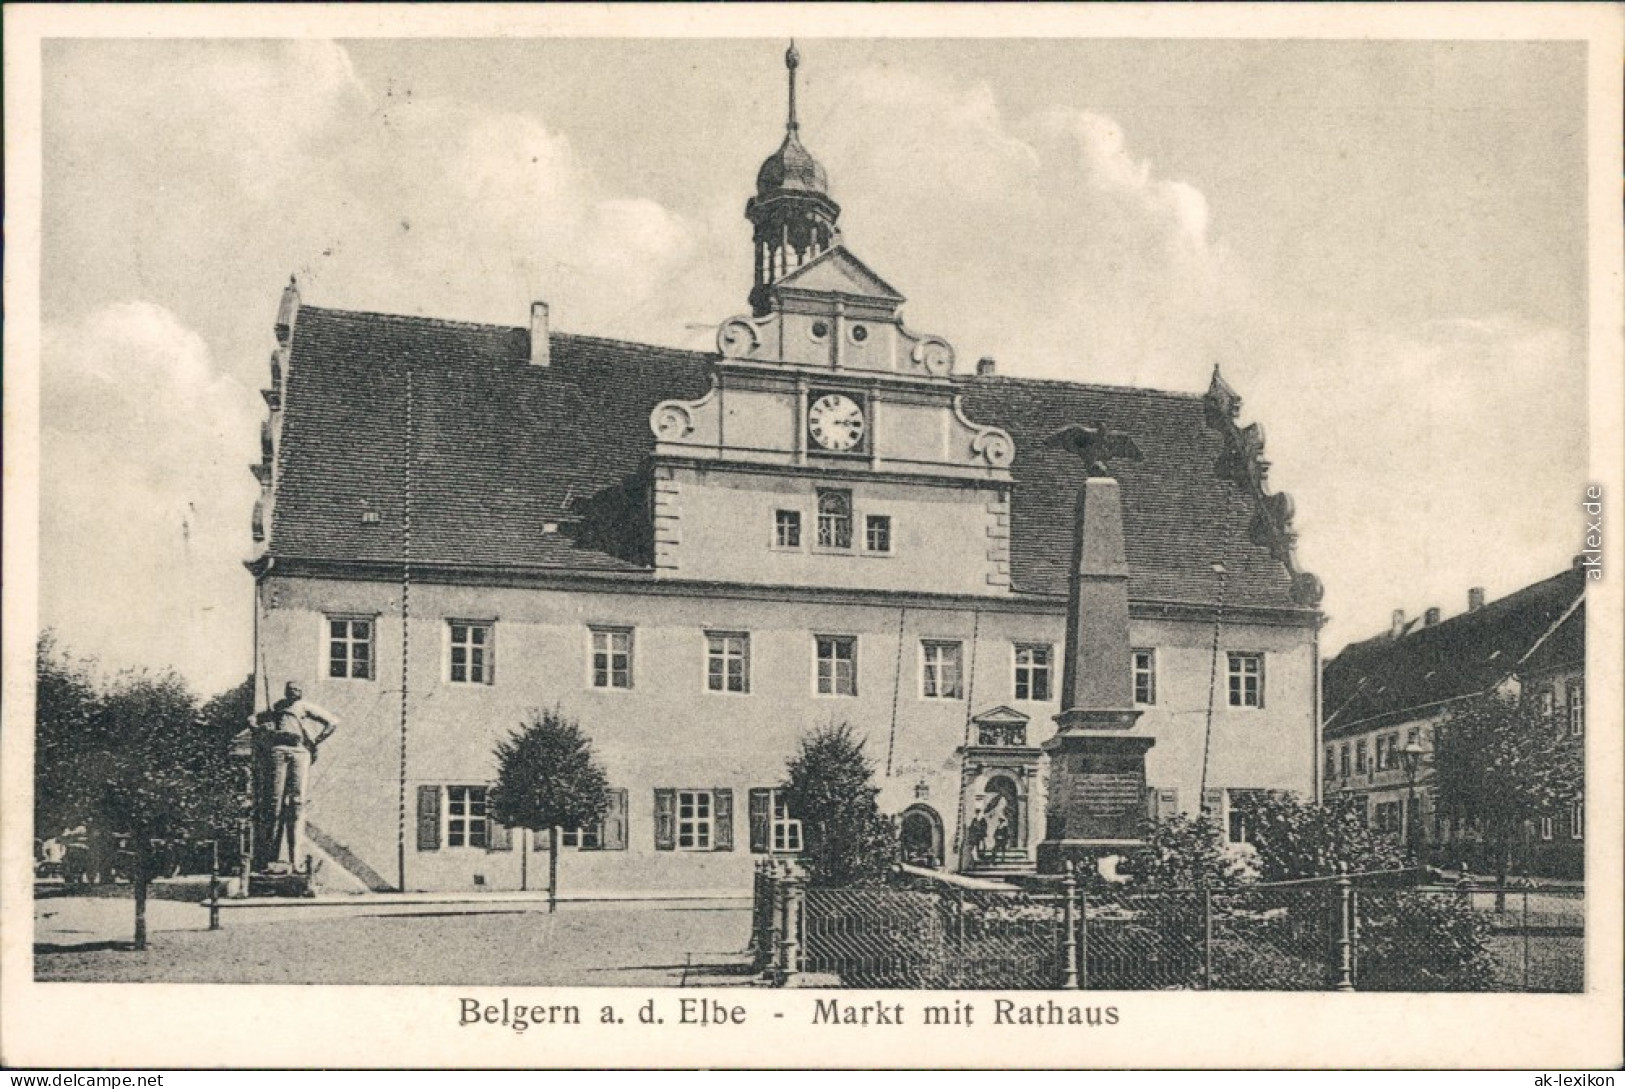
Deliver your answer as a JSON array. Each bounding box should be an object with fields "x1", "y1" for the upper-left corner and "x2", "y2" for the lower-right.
[{"x1": 744, "y1": 42, "x2": 840, "y2": 317}]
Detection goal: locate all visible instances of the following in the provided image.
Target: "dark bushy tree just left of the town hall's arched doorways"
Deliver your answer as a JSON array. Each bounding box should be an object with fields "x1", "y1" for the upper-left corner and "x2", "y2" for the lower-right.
[{"x1": 783, "y1": 723, "x2": 900, "y2": 887}]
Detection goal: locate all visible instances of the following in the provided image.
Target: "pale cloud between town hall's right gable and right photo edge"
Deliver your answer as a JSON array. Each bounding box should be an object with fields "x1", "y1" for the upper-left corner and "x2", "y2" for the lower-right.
[{"x1": 1227, "y1": 315, "x2": 1586, "y2": 650}]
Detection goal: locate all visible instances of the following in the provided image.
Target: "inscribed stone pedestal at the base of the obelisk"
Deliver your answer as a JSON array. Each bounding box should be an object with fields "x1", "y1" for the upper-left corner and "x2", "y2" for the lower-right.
[{"x1": 1037, "y1": 709, "x2": 1155, "y2": 873}]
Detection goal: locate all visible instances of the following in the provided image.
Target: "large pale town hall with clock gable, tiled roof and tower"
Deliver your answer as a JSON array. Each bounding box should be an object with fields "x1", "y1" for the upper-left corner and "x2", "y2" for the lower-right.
[{"x1": 250, "y1": 46, "x2": 1321, "y2": 889}]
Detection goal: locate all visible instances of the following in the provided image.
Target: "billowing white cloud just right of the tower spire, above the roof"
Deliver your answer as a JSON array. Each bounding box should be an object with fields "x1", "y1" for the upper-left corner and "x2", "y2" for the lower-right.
[{"x1": 809, "y1": 70, "x2": 1246, "y2": 388}]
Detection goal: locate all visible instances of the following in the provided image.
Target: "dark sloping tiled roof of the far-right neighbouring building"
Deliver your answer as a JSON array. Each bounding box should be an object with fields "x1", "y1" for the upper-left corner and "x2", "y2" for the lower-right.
[{"x1": 1323, "y1": 569, "x2": 1586, "y2": 736}]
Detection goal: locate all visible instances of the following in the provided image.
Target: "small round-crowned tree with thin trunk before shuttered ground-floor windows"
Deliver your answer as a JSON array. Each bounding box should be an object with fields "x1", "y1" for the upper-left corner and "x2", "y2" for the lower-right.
[{"x1": 491, "y1": 709, "x2": 609, "y2": 910}]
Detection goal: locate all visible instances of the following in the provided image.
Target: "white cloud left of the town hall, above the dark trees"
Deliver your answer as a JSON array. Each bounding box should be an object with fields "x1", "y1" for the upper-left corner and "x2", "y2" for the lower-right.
[{"x1": 41, "y1": 302, "x2": 263, "y2": 694}]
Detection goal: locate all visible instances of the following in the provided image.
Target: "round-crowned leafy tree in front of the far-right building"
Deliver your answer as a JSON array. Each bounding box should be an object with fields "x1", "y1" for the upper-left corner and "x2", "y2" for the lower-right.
[{"x1": 1433, "y1": 692, "x2": 1584, "y2": 896}]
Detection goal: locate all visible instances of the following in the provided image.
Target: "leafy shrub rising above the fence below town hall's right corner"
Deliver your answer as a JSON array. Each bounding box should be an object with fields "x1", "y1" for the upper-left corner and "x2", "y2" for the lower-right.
[{"x1": 1235, "y1": 795, "x2": 1406, "y2": 881}]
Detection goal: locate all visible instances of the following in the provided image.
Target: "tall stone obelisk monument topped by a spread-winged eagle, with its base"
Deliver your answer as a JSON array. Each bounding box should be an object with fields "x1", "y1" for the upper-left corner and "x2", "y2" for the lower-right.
[{"x1": 1037, "y1": 426, "x2": 1155, "y2": 873}]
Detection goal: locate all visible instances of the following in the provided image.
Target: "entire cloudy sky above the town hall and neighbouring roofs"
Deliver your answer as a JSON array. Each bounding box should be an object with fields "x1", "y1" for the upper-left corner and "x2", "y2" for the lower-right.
[{"x1": 41, "y1": 39, "x2": 1588, "y2": 692}]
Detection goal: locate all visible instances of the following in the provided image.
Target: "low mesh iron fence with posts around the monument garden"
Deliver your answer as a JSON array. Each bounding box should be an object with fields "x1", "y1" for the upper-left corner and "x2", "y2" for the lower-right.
[{"x1": 751, "y1": 863, "x2": 1584, "y2": 991}]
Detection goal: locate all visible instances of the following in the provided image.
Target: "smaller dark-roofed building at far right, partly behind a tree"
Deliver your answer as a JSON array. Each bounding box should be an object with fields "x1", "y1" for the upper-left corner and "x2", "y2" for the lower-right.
[{"x1": 1321, "y1": 567, "x2": 1586, "y2": 876}]
